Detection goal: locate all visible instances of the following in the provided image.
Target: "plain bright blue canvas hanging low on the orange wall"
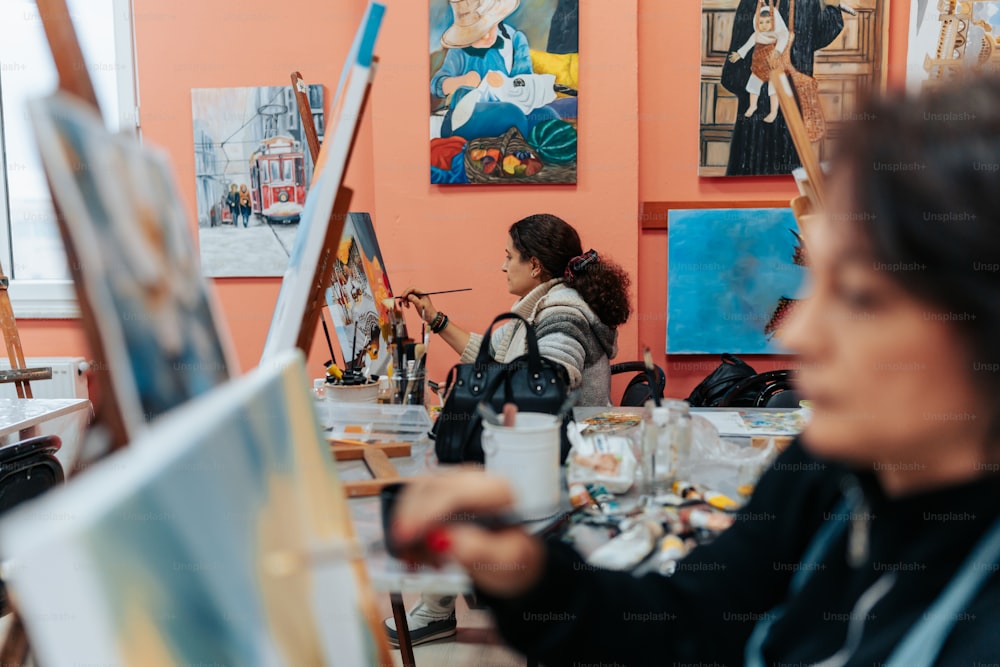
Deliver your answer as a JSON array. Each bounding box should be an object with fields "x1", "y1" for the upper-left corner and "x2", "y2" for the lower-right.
[{"x1": 667, "y1": 208, "x2": 806, "y2": 354}]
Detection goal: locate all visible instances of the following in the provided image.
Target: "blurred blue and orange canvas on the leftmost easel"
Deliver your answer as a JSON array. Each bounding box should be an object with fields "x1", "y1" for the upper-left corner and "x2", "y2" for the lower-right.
[{"x1": 30, "y1": 92, "x2": 236, "y2": 444}]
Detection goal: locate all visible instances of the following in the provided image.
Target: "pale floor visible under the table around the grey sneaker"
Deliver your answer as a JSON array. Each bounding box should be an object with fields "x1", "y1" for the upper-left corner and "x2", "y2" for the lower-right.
[{"x1": 375, "y1": 593, "x2": 526, "y2": 667}]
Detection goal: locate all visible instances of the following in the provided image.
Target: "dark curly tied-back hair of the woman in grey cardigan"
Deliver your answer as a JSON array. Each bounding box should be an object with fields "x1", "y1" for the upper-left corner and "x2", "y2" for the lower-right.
[{"x1": 510, "y1": 213, "x2": 632, "y2": 327}]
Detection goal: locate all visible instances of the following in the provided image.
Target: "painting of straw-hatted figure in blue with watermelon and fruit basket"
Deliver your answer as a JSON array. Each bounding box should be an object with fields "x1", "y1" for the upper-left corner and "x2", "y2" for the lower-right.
[{"x1": 428, "y1": 0, "x2": 579, "y2": 185}]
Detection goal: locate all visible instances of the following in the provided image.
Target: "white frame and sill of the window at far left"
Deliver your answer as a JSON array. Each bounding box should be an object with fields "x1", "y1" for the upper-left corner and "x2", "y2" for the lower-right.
[{"x1": 0, "y1": 0, "x2": 140, "y2": 319}]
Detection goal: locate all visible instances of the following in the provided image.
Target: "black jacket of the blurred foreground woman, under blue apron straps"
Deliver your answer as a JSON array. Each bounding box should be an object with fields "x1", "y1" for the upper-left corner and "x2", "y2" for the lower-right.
[{"x1": 480, "y1": 442, "x2": 1000, "y2": 667}]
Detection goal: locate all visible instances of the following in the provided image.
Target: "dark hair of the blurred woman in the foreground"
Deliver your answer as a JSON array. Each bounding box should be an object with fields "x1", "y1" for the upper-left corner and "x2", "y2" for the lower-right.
[{"x1": 836, "y1": 77, "x2": 1000, "y2": 437}]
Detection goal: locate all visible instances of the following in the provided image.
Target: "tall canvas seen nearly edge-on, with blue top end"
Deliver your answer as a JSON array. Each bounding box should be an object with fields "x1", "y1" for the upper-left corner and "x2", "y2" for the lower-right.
[{"x1": 261, "y1": 2, "x2": 385, "y2": 361}]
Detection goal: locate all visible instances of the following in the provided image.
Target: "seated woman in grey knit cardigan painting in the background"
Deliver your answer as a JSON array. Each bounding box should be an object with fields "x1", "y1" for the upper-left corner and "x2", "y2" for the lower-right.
[{"x1": 386, "y1": 214, "x2": 630, "y2": 645}]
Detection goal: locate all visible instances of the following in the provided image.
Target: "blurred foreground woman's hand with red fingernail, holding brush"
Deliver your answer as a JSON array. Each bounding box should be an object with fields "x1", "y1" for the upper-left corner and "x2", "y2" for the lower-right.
[{"x1": 386, "y1": 470, "x2": 545, "y2": 597}]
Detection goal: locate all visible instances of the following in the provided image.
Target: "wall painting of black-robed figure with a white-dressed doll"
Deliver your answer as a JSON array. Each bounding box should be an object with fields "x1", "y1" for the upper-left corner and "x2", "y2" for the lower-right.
[{"x1": 698, "y1": 0, "x2": 889, "y2": 176}]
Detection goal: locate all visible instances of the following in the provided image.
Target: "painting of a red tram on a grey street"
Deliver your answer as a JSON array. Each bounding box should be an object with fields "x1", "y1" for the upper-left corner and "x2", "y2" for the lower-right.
[{"x1": 191, "y1": 85, "x2": 325, "y2": 277}]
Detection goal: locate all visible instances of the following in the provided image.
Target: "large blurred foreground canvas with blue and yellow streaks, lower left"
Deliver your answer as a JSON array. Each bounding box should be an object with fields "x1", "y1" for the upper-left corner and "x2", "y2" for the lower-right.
[{"x1": 0, "y1": 352, "x2": 391, "y2": 667}]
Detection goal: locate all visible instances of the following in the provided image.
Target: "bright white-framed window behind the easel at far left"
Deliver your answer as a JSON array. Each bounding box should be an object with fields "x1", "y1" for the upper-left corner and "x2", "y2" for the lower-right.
[{"x1": 0, "y1": 0, "x2": 137, "y2": 318}]
